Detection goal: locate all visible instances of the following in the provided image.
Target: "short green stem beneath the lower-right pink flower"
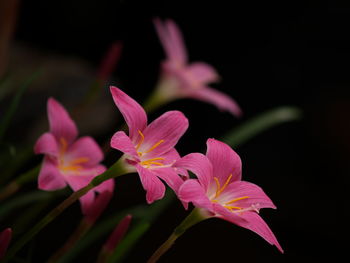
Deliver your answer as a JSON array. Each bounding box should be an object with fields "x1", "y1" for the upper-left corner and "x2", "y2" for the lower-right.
[{"x1": 147, "y1": 208, "x2": 206, "y2": 263}]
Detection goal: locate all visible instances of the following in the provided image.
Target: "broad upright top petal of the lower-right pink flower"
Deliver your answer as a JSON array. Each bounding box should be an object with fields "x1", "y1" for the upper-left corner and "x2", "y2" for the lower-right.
[{"x1": 206, "y1": 139, "x2": 242, "y2": 185}]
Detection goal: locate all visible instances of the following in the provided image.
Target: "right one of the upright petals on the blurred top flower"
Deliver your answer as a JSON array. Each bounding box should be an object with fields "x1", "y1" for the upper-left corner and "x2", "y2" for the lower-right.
[{"x1": 165, "y1": 19, "x2": 187, "y2": 64}]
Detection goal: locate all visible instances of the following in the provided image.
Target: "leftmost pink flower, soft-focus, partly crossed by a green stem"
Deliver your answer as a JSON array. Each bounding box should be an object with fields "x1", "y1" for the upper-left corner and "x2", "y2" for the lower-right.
[{"x1": 34, "y1": 98, "x2": 114, "y2": 214}]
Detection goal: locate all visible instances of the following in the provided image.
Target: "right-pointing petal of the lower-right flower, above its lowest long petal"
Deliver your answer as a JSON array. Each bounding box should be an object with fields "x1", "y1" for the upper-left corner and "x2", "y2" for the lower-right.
[{"x1": 220, "y1": 181, "x2": 276, "y2": 209}]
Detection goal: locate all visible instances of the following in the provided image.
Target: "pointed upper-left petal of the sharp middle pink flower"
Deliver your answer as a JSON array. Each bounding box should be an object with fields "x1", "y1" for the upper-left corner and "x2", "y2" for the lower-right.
[{"x1": 110, "y1": 86, "x2": 147, "y2": 143}]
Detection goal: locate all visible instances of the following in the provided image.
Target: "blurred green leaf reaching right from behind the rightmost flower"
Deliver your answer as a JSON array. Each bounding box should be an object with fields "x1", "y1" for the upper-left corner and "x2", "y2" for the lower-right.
[{"x1": 222, "y1": 106, "x2": 302, "y2": 147}]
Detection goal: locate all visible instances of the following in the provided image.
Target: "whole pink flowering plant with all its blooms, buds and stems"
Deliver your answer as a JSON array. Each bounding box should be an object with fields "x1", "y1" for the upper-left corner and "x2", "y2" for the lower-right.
[{"x1": 0, "y1": 14, "x2": 298, "y2": 262}]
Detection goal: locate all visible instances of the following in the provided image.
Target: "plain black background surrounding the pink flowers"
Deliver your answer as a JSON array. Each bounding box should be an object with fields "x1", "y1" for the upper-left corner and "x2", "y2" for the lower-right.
[{"x1": 1, "y1": 0, "x2": 350, "y2": 262}]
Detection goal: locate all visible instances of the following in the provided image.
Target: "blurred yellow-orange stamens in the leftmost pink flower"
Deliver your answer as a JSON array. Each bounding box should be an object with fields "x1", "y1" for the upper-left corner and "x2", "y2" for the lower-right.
[{"x1": 58, "y1": 138, "x2": 89, "y2": 173}]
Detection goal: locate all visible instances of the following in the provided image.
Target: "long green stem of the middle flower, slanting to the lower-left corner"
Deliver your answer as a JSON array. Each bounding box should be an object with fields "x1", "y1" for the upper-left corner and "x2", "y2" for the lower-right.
[{"x1": 4, "y1": 159, "x2": 127, "y2": 262}]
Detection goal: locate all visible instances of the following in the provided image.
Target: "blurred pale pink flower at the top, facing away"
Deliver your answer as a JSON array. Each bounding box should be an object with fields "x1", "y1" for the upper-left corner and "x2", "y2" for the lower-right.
[{"x1": 154, "y1": 19, "x2": 242, "y2": 116}]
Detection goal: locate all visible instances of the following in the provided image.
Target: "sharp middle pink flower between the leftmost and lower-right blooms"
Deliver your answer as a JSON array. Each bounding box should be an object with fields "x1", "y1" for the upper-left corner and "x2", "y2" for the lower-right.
[{"x1": 111, "y1": 87, "x2": 188, "y2": 203}]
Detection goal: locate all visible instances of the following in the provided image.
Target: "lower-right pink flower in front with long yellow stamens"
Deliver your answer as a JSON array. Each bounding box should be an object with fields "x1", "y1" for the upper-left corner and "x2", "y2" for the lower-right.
[{"x1": 175, "y1": 139, "x2": 283, "y2": 252}]
